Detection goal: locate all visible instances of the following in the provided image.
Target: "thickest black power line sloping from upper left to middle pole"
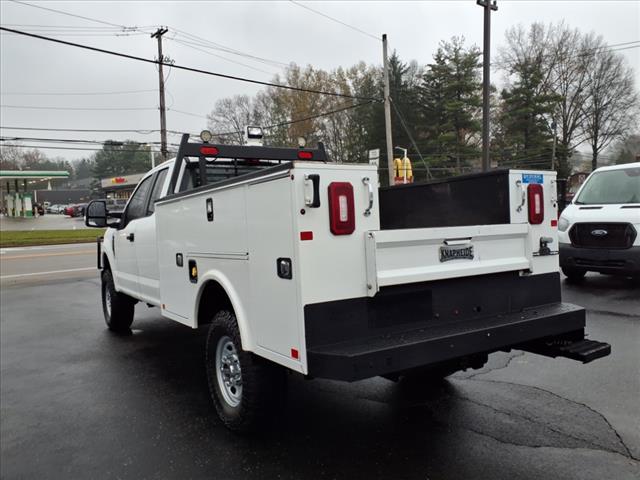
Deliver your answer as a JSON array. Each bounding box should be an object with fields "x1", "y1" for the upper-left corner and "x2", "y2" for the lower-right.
[{"x1": 0, "y1": 26, "x2": 379, "y2": 101}]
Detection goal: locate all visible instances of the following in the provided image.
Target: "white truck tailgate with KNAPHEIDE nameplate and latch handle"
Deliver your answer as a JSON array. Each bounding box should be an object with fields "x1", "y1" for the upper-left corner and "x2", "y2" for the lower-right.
[{"x1": 365, "y1": 224, "x2": 531, "y2": 296}]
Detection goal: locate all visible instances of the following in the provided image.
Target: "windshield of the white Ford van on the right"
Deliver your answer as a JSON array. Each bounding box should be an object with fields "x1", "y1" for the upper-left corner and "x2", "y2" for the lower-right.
[{"x1": 575, "y1": 167, "x2": 640, "y2": 205}]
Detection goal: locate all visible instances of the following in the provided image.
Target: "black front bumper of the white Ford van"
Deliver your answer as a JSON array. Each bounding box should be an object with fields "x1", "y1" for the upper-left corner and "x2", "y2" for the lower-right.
[{"x1": 560, "y1": 243, "x2": 640, "y2": 275}]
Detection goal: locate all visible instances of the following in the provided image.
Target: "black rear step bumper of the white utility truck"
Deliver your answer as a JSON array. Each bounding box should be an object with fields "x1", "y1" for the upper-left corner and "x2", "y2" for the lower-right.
[{"x1": 307, "y1": 303, "x2": 611, "y2": 381}]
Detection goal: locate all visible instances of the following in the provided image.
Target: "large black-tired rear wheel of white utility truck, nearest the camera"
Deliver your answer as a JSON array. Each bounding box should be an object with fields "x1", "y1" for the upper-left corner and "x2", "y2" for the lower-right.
[{"x1": 206, "y1": 310, "x2": 285, "y2": 433}]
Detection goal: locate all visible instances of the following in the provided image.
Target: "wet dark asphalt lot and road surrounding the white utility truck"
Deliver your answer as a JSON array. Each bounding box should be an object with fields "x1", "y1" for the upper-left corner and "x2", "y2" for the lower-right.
[{"x1": 0, "y1": 245, "x2": 640, "y2": 480}]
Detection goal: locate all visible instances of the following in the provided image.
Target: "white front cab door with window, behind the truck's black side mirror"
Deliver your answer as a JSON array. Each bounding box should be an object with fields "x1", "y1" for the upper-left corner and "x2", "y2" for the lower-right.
[{"x1": 113, "y1": 175, "x2": 154, "y2": 296}]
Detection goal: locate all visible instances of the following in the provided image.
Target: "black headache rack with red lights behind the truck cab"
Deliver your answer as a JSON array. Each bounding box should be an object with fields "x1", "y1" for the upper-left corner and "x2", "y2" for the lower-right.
[{"x1": 169, "y1": 133, "x2": 328, "y2": 192}]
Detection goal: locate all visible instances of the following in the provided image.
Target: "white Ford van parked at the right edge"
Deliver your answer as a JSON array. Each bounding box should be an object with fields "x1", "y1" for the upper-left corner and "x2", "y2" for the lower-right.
[{"x1": 558, "y1": 162, "x2": 640, "y2": 281}]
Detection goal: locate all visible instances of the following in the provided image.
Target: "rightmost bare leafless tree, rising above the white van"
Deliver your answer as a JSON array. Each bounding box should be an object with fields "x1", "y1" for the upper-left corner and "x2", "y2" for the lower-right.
[{"x1": 582, "y1": 45, "x2": 639, "y2": 170}]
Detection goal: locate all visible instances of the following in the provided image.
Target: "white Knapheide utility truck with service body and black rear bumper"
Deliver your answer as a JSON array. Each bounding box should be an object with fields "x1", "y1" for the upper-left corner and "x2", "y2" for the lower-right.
[{"x1": 85, "y1": 130, "x2": 610, "y2": 431}]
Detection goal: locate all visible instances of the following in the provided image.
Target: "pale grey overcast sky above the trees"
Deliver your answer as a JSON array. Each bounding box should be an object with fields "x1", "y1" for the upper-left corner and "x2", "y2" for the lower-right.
[{"x1": 0, "y1": 0, "x2": 640, "y2": 159}]
